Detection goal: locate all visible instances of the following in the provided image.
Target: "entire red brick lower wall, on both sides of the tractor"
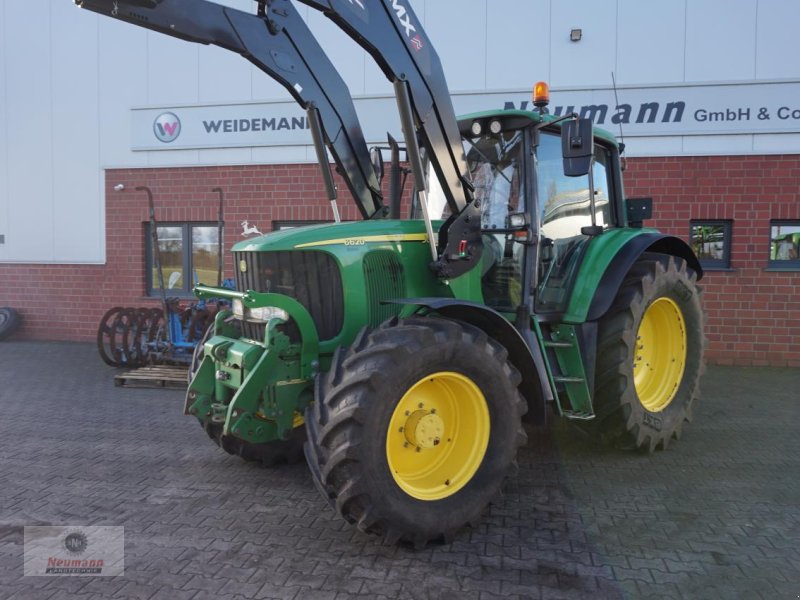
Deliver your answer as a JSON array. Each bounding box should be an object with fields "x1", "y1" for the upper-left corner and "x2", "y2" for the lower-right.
[{"x1": 0, "y1": 156, "x2": 800, "y2": 366}]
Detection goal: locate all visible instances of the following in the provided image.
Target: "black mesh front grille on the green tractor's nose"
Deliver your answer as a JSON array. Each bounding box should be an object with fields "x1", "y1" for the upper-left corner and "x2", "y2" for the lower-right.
[{"x1": 234, "y1": 251, "x2": 344, "y2": 341}]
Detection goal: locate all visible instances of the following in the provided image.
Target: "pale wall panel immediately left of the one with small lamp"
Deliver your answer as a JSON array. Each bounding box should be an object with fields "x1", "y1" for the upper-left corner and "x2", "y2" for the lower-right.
[{"x1": 482, "y1": 0, "x2": 550, "y2": 90}]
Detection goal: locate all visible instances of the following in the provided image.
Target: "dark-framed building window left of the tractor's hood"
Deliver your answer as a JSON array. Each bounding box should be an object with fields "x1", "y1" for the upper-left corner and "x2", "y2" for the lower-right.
[{"x1": 145, "y1": 223, "x2": 219, "y2": 296}]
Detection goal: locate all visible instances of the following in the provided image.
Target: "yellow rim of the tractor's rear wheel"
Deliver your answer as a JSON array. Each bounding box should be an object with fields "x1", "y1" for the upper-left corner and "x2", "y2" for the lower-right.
[{"x1": 633, "y1": 298, "x2": 686, "y2": 412}]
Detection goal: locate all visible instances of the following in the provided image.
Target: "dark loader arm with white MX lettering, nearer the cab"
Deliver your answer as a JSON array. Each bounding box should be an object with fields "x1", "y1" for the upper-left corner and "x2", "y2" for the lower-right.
[{"x1": 294, "y1": 0, "x2": 483, "y2": 278}]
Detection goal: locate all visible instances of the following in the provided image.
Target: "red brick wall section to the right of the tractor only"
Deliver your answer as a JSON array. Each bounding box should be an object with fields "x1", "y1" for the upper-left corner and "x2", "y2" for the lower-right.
[{"x1": 625, "y1": 155, "x2": 800, "y2": 367}]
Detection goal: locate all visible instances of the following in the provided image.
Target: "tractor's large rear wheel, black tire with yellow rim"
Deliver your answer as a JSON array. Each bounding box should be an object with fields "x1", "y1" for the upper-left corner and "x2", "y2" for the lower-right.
[{"x1": 590, "y1": 254, "x2": 705, "y2": 452}]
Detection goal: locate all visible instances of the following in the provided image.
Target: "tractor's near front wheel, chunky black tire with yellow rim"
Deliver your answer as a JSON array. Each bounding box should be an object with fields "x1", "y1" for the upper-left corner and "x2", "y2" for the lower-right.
[{"x1": 305, "y1": 318, "x2": 527, "y2": 547}]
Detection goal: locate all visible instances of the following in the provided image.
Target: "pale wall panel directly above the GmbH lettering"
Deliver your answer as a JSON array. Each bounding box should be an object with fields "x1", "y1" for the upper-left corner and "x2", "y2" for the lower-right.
[{"x1": 686, "y1": 0, "x2": 758, "y2": 81}]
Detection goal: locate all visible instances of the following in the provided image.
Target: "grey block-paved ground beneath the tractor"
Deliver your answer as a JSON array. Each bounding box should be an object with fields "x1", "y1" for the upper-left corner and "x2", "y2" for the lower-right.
[{"x1": 0, "y1": 342, "x2": 800, "y2": 600}]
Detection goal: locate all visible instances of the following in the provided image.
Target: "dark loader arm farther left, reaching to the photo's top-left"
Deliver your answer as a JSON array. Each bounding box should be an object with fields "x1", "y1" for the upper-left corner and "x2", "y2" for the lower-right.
[{"x1": 75, "y1": 0, "x2": 387, "y2": 219}]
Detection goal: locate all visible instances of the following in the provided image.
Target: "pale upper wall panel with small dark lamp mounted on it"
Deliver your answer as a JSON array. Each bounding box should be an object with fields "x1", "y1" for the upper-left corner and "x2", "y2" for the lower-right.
[{"x1": 550, "y1": 0, "x2": 617, "y2": 87}]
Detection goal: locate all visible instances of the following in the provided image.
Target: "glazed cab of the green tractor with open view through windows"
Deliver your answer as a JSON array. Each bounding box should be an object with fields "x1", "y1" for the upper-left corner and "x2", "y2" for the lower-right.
[{"x1": 418, "y1": 103, "x2": 624, "y2": 314}]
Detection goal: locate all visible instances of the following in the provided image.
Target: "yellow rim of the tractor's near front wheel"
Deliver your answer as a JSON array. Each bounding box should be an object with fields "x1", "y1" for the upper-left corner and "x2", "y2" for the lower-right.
[{"x1": 386, "y1": 371, "x2": 491, "y2": 501}]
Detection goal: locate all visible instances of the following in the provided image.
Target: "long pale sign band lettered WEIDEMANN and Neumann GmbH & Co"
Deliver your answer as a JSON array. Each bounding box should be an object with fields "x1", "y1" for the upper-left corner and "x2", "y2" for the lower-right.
[{"x1": 132, "y1": 82, "x2": 800, "y2": 151}]
